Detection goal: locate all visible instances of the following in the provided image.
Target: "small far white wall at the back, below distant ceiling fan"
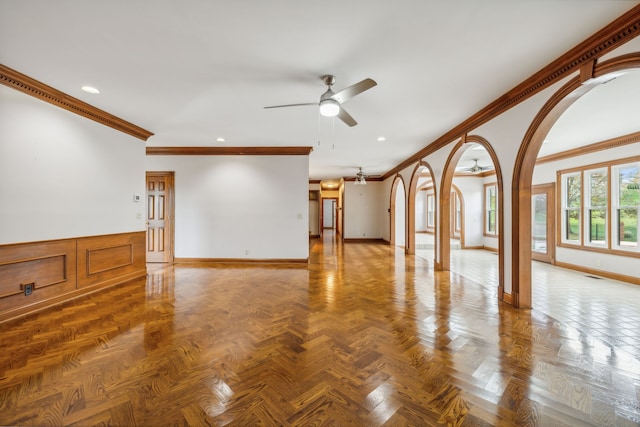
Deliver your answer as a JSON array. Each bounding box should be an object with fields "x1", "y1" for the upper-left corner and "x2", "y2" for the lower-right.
[{"x1": 344, "y1": 181, "x2": 387, "y2": 239}]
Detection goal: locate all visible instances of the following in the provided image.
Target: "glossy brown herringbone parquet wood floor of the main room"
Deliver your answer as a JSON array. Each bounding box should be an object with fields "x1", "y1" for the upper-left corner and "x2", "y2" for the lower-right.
[{"x1": 0, "y1": 236, "x2": 640, "y2": 426}]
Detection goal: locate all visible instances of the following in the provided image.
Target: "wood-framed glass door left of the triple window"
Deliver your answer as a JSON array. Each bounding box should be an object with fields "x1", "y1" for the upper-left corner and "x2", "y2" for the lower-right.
[{"x1": 531, "y1": 183, "x2": 556, "y2": 264}]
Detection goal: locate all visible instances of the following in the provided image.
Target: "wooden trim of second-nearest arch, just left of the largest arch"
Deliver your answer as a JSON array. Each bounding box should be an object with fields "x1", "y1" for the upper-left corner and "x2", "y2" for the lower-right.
[{"x1": 436, "y1": 135, "x2": 505, "y2": 300}]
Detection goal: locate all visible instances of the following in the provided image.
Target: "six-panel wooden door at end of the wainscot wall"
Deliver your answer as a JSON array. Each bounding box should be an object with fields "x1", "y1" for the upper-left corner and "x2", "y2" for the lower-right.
[{"x1": 147, "y1": 172, "x2": 174, "y2": 262}]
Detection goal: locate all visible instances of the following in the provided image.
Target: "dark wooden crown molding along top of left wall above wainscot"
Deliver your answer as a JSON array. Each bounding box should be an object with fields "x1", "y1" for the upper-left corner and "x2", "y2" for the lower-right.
[{"x1": 0, "y1": 64, "x2": 153, "y2": 141}]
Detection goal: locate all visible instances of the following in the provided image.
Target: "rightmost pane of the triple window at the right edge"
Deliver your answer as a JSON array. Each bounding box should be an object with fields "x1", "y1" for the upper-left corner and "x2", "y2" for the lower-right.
[{"x1": 612, "y1": 162, "x2": 640, "y2": 250}]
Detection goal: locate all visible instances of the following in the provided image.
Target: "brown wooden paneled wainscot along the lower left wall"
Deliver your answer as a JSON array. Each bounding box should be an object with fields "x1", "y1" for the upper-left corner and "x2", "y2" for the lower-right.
[{"x1": 0, "y1": 232, "x2": 146, "y2": 322}]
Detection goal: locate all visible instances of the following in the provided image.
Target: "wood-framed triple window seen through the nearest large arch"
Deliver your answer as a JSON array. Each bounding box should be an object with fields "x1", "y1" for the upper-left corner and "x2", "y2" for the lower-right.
[{"x1": 558, "y1": 157, "x2": 640, "y2": 254}]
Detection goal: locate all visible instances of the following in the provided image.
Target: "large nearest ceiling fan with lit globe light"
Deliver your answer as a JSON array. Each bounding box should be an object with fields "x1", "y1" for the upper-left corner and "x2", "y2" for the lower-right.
[{"x1": 264, "y1": 75, "x2": 377, "y2": 126}]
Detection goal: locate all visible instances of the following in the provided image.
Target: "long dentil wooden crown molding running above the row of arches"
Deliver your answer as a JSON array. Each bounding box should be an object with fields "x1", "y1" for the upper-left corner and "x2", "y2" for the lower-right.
[{"x1": 383, "y1": 5, "x2": 640, "y2": 179}]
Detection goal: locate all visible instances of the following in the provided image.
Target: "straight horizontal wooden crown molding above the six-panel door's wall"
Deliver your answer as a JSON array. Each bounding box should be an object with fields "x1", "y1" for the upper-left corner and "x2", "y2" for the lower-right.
[{"x1": 147, "y1": 147, "x2": 313, "y2": 156}]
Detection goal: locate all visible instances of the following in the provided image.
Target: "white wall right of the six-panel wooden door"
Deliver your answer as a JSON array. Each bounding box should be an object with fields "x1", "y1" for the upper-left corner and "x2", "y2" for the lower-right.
[{"x1": 146, "y1": 155, "x2": 309, "y2": 260}]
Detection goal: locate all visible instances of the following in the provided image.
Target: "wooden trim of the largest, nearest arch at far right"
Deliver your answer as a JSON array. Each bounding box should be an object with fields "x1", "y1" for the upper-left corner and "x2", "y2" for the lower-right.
[{"x1": 511, "y1": 52, "x2": 640, "y2": 308}]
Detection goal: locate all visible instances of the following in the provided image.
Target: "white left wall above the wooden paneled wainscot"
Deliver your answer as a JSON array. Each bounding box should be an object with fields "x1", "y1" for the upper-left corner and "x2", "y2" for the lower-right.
[{"x1": 0, "y1": 86, "x2": 145, "y2": 244}]
